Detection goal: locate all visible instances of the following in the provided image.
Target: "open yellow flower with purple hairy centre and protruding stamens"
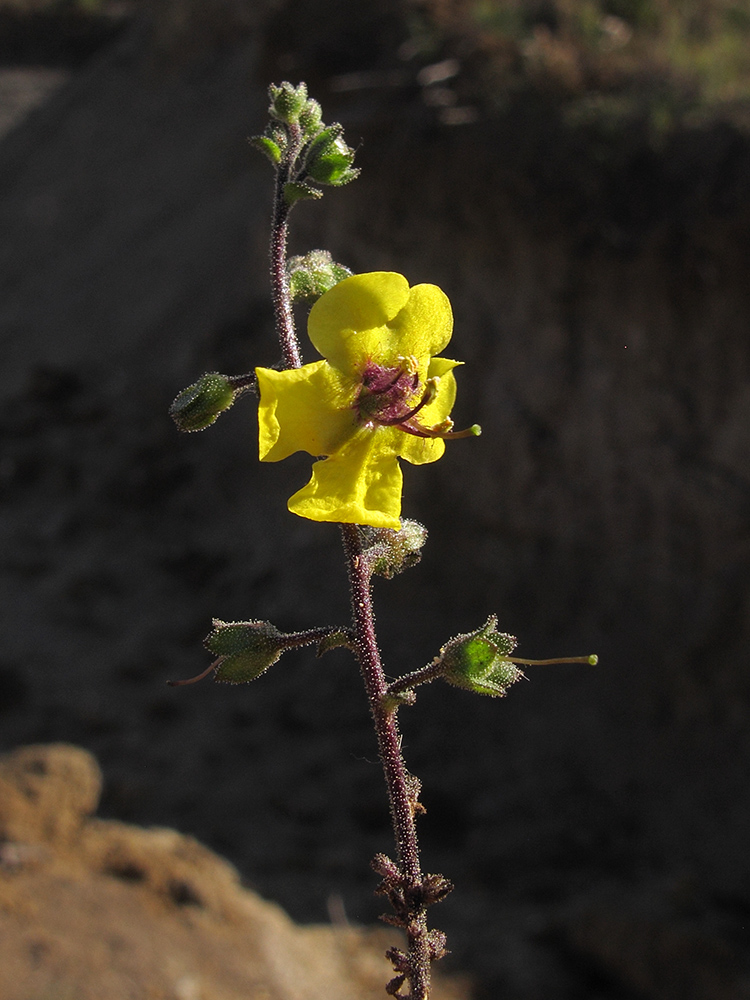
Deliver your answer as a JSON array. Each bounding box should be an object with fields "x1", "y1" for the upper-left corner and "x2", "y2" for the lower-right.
[{"x1": 256, "y1": 271, "x2": 479, "y2": 529}]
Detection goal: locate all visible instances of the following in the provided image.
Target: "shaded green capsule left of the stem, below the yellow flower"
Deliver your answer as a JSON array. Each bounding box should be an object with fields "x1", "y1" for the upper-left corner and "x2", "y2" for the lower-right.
[{"x1": 204, "y1": 619, "x2": 289, "y2": 684}]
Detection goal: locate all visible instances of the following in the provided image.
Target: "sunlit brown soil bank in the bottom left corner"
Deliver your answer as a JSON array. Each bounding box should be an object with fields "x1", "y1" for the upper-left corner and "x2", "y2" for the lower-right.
[{"x1": 0, "y1": 744, "x2": 466, "y2": 1000}]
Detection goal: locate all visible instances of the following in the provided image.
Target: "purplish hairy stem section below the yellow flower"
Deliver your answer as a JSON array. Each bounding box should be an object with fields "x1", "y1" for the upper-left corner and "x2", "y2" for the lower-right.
[{"x1": 341, "y1": 524, "x2": 430, "y2": 1000}]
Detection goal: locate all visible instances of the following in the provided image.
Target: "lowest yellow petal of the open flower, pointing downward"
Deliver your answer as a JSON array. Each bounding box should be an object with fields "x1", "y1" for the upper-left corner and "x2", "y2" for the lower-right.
[{"x1": 288, "y1": 431, "x2": 406, "y2": 530}]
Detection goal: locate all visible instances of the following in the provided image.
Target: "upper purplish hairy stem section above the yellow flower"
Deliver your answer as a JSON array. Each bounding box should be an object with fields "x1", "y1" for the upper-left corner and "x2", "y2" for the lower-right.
[{"x1": 271, "y1": 125, "x2": 302, "y2": 368}]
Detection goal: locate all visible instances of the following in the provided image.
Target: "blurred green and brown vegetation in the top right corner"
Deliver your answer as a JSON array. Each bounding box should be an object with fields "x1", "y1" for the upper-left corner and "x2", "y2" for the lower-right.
[{"x1": 467, "y1": 0, "x2": 750, "y2": 114}]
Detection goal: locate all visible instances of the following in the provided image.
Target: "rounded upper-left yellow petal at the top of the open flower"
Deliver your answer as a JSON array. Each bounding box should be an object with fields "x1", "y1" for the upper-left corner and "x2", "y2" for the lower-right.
[{"x1": 307, "y1": 271, "x2": 412, "y2": 373}]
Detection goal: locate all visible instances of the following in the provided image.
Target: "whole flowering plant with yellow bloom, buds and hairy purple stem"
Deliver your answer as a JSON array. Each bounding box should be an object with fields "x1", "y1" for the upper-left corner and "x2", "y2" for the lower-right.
[{"x1": 170, "y1": 82, "x2": 596, "y2": 1000}]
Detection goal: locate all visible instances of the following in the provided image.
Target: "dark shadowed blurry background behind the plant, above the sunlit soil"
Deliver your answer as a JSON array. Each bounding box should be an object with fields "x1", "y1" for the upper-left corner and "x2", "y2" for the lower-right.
[{"x1": 0, "y1": 0, "x2": 750, "y2": 1000}]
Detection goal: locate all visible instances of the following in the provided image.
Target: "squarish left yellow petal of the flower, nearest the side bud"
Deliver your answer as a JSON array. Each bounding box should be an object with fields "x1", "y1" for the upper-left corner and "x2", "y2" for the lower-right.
[{"x1": 255, "y1": 361, "x2": 357, "y2": 462}]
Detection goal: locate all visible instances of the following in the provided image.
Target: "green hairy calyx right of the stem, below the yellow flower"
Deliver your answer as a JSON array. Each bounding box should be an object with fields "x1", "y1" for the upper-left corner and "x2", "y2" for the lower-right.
[{"x1": 439, "y1": 615, "x2": 524, "y2": 698}]
